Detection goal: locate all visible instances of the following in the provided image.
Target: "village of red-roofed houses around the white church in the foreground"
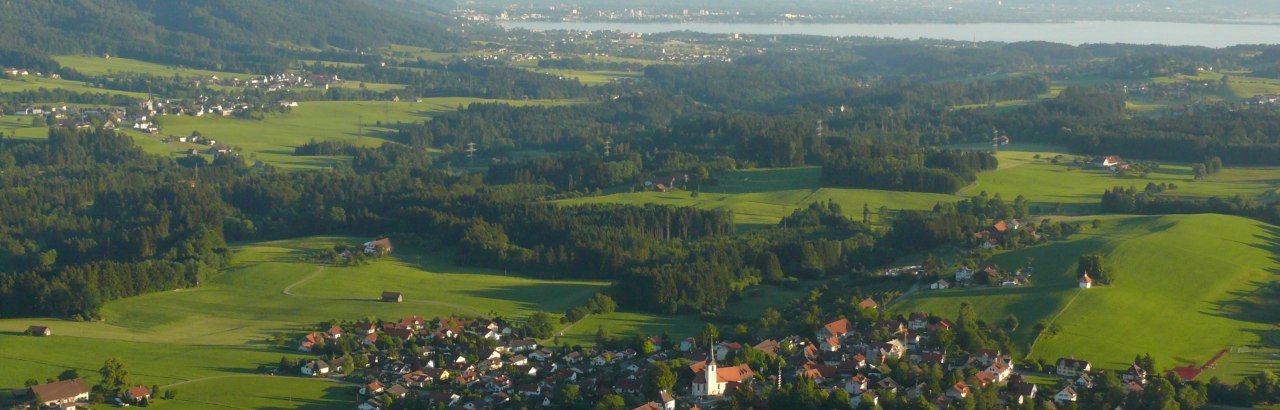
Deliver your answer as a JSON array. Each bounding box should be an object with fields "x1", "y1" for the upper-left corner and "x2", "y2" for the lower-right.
[{"x1": 264, "y1": 299, "x2": 1199, "y2": 410}]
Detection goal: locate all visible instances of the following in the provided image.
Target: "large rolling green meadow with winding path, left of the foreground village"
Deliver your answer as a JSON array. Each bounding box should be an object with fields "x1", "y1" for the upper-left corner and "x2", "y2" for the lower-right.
[{"x1": 0, "y1": 237, "x2": 614, "y2": 399}]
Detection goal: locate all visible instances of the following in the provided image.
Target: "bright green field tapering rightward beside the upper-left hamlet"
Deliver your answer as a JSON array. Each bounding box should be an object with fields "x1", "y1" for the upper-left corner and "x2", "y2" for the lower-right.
[{"x1": 161, "y1": 97, "x2": 571, "y2": 168}]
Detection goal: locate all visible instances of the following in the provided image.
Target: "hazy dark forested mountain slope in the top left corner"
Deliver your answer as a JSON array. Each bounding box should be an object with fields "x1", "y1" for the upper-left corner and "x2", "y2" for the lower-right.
[{"x1": 0, "y1": 0, "x2": 461, "y2": 72}]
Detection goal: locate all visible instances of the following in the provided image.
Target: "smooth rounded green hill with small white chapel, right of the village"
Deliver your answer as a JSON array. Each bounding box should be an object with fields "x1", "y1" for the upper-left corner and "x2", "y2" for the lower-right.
[{"x1": 893, "y1": 215, "x2": 1280, "y2": 381}]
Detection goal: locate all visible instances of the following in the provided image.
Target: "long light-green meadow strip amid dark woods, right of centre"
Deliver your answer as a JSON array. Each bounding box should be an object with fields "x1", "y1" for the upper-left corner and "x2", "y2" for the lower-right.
[{"x1": 561, "y1": 144, "x2": 1280, "y2": 227}]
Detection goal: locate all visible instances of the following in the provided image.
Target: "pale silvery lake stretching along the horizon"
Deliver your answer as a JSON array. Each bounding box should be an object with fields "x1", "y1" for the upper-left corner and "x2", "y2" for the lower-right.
[{"x1": 503, "y1": 21, "x2": 1280, "y2": 47}]
